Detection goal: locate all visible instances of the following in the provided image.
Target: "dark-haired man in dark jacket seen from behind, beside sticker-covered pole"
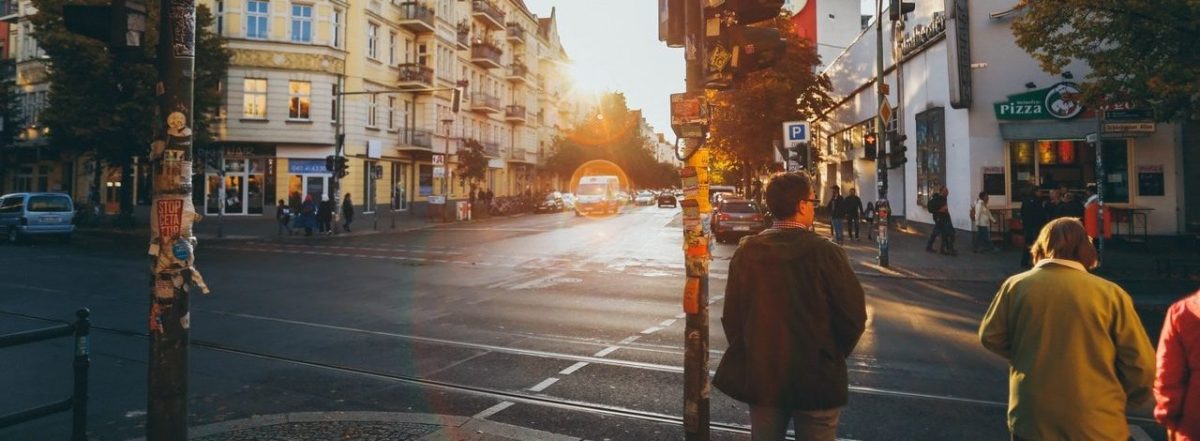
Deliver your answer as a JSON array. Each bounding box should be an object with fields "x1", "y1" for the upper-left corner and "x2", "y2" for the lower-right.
[{"x1": 713, "y1": 174, "x2": 866, "y2": 441}]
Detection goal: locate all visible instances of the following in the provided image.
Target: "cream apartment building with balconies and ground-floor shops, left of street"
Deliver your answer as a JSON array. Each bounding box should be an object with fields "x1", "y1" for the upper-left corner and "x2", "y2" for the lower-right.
[{"x1": 0, "y1": 0, "x2": 575, "y2": 217}]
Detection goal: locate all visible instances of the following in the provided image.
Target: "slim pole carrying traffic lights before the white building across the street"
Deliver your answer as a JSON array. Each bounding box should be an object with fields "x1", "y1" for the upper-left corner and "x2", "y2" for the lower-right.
[{"x1": 875, "y1": 0, "x2": 900, "y2": 266}]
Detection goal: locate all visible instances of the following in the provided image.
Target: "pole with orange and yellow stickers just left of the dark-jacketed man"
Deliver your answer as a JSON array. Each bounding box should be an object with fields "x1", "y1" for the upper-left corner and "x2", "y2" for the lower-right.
[{"x1": 683, "y1": 0, "x2": 712, "y2": 441}]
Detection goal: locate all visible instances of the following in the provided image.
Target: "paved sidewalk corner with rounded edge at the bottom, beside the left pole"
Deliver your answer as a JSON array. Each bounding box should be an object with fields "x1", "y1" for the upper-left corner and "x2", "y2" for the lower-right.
[{"x1": 130, "y1": 412, "x2": 580, "y2": 441}]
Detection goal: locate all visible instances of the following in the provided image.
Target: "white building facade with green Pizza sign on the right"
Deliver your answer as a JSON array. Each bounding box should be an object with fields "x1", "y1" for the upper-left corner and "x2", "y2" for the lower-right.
[{"x1": 814, "y1": 0, "x2": 1200, "y2": 235}]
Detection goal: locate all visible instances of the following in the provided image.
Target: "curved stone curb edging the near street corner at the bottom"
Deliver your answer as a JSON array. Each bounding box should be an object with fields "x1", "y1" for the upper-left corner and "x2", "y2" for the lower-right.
[{"x1": 127, "y1": 411, "x2": 581, "y2": 441}]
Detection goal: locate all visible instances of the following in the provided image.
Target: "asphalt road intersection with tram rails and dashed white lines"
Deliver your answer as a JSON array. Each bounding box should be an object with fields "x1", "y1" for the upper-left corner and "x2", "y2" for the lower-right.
[{"x1": 0, "y1": 207, "x2": 1164, "y2": 441}]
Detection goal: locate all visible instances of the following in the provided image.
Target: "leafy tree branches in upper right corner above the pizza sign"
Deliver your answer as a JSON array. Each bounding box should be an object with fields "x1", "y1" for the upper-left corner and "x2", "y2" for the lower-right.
[{"x1": 1013, "y1": 0, "x2": 1200, "y2": 121}]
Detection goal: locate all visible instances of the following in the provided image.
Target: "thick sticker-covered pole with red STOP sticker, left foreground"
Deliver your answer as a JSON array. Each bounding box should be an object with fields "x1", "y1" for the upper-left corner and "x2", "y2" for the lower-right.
[{"x1": 146, "y1": 0, "x2": 208, "y2": 441}]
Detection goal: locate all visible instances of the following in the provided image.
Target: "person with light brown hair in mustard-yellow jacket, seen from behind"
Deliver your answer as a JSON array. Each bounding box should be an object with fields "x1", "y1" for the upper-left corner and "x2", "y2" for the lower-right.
[{"x1": 979, "y1": 218, "x2": 1154, "y2": 441}]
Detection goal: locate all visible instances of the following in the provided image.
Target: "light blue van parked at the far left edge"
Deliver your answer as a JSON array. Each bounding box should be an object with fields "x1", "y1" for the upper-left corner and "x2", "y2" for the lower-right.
[{"x1": 0, "y1": 193, "x2": 74, "y2": 243}]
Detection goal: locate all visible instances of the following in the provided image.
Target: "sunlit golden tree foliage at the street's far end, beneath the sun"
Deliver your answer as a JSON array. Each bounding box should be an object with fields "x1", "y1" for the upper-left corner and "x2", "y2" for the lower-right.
[{"x1": 546, "y1": 92, "x2": 679, "y2": 188}]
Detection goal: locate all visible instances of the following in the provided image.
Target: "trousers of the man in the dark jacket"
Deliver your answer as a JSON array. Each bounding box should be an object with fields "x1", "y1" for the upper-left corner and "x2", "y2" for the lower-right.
[{"x1": 750, "y1": 405, "x2": 841, "y2": 441}]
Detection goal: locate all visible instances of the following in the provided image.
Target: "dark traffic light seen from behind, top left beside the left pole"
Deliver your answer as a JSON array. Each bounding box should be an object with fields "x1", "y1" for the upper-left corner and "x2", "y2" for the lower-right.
[{"x1": 62, "y1": 0, "x2": 146, "y2": 58}]
